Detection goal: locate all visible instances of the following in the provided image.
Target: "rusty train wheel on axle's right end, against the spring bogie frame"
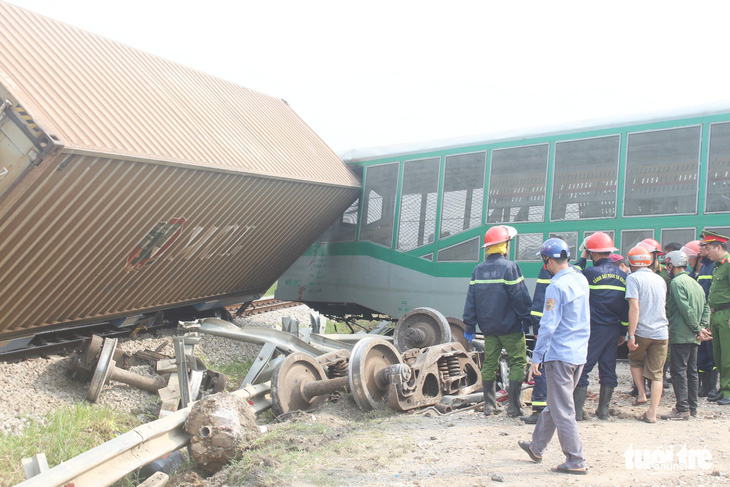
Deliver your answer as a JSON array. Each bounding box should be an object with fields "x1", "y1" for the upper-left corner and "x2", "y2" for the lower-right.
[{"x1": 350, "y1": 337, "x2": 403, "y2": 411}]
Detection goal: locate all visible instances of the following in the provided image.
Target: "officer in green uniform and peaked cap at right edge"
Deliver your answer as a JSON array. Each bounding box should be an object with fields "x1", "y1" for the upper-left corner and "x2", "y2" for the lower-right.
[{"x1": 703, "y1": 230, "x2": 730, "y2": 406}]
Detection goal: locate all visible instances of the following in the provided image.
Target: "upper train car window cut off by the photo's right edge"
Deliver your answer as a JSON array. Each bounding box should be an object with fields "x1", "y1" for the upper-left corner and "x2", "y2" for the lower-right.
[{"x1": 705, "y1": 122, "x2": 730, "y2": 213}]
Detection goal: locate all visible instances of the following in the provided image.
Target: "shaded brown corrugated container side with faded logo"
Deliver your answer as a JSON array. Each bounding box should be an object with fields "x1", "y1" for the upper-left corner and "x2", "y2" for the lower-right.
[{"x1": 0, "y1": 154, "x2": 359, "y2": 335}]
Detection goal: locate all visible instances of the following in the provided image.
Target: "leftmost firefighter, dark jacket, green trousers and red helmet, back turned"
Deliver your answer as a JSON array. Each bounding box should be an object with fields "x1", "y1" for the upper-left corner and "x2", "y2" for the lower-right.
[{"x1": 463, "y1": 225, "x2": 531, "y2": 417}]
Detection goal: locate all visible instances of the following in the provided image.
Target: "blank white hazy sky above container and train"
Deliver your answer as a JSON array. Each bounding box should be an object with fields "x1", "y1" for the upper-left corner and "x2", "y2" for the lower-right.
[{"x1": 5, "y1": 0, "x2": 730, "y2": 151}]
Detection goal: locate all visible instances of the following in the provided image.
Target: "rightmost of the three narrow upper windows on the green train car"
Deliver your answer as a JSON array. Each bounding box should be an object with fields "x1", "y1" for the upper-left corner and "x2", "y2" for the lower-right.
[{"x1": 440, "y1": 152, "x2": 487, "y2": 238}]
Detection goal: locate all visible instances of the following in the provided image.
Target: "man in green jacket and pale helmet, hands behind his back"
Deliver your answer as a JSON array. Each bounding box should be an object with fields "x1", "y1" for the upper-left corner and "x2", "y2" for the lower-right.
[{"x1": 661, "y1": 250, "x2": 710, "y2": 420}]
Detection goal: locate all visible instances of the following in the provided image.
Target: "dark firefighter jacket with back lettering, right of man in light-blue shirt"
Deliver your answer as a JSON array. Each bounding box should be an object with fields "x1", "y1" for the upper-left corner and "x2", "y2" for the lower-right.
[{"x1": 577, "y1": 258, "x2": 629, "y2": 327}]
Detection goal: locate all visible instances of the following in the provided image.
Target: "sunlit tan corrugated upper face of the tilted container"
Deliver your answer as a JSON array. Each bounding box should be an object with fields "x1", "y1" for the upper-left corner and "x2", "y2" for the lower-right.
[{"x1": 0, "y1": 1, "x2": 360, "y2": 187}]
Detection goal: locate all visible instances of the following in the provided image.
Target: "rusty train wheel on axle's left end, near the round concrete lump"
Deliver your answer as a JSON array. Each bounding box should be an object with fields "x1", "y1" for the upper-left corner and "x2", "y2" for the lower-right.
[{"x1": 271, "y1": 352, "x2": 328, "y2": 416}]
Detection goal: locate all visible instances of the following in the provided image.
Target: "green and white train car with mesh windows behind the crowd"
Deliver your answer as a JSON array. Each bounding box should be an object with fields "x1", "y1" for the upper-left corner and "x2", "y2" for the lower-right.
[{"x1": 276, "y1": 103, "x2": 730, "y2": 319}]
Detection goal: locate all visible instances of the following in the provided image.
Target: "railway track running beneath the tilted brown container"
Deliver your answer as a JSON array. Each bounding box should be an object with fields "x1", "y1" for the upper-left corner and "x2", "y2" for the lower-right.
[{"x1": 0, "y1": 299, "x2": 301, "y2": 362}]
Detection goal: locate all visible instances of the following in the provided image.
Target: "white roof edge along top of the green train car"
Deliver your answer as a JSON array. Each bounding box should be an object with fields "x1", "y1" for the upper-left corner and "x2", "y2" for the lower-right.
[{"x1": 338, "y1": 100, "x2": 730, "y2": 163}]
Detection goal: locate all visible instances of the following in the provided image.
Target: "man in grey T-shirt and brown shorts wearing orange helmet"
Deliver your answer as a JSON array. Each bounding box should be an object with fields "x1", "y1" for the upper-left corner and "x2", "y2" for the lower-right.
[{"x1": 626, "y1": 245, "x2": 669, "y2": 423}]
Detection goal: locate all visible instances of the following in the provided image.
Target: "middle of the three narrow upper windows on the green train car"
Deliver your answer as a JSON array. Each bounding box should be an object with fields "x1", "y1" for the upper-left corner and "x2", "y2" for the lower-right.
[{"x1": 398, "y1": 157, "x2": 441, "y2": 252}]
